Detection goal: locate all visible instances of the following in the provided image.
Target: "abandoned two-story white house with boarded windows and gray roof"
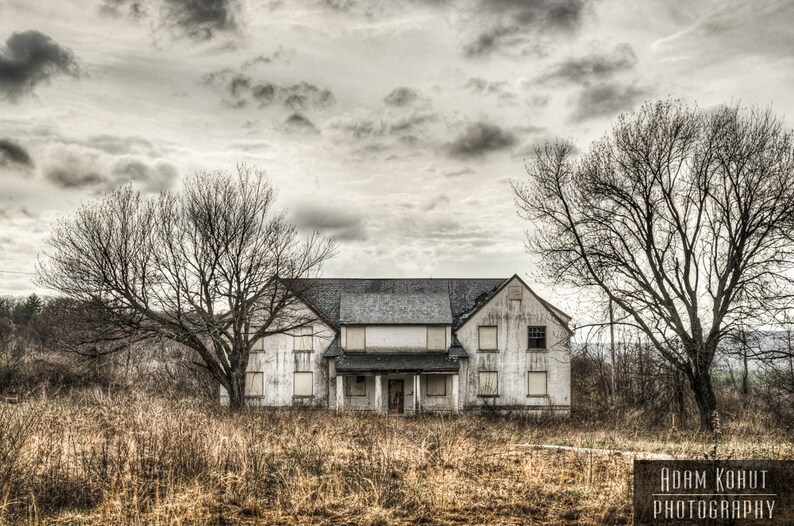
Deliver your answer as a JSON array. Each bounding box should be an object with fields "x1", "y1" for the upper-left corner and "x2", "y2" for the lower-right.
[{"x1": 222, "y1": 276, "x2": 571, "y2": 413}]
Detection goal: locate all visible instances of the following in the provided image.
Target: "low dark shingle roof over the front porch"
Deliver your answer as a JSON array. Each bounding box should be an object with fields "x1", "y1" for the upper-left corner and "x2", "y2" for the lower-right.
[{"x1": 335, "y1": 353, "x2": 459, "y2": 373}]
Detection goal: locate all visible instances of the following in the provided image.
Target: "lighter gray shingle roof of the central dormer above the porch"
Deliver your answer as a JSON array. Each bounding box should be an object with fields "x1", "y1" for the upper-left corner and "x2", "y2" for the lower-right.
[{"x1": 339, "y1": 292, "x2": 452, "y2": 325}]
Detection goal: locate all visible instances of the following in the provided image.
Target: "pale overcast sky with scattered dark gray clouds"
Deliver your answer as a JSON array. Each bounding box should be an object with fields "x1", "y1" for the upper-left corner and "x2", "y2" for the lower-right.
[{"x1": 0, "y1": 0, "x2": 794, "y2": 318}]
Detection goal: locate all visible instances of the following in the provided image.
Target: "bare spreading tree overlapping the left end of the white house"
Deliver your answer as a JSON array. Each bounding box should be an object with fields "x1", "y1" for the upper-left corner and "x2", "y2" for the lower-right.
[{"x1": 38, "y1": 166, "x2": 335, "y2": 409}]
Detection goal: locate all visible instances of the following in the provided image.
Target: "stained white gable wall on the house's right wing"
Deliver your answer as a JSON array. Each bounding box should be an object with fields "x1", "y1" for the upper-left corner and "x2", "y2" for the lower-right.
[{"x1": 457, "y1": 279, "x2": 571, "y2": 410}]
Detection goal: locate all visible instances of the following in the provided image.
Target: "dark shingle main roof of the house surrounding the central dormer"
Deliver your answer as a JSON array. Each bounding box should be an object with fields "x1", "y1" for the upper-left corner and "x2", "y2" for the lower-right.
[{"x1": 296, "y1": 278, "x2": 505, "y2": 327}]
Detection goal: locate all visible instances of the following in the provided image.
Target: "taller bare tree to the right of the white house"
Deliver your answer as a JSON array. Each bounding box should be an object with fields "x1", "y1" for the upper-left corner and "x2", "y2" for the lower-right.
[{"x1": 514, "y1": 101, "x2": 794, "y2": 430}]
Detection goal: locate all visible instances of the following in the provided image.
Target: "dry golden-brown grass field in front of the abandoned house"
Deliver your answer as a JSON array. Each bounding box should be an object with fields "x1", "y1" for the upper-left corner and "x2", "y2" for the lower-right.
[{"x1": 0, "y1": 391, "x2": 794, "y2": 525}]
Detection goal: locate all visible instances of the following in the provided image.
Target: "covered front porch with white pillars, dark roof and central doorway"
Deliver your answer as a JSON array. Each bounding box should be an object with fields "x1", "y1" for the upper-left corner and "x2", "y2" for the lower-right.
[{"x1": 335, "y1": 353, "x2": 460, "y2": 414}]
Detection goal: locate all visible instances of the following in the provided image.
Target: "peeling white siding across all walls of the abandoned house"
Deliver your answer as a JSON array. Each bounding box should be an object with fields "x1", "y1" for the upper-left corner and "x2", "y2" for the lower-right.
[{"x1": 221, "y1": 278, "x2": 571, "y2": 414}]
